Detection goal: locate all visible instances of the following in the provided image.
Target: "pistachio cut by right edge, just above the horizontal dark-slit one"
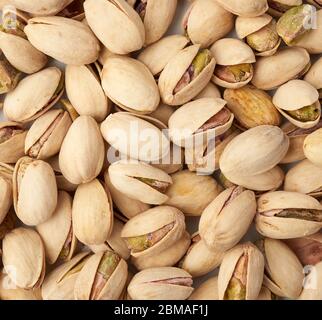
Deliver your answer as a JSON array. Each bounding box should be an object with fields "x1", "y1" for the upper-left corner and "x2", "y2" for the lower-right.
[{"x1": 284, "y1": 159, "x2": 322, "y2": 197}]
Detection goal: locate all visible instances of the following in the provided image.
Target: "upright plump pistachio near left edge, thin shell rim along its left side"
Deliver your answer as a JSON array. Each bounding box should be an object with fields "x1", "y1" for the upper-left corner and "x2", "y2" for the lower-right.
[{"x1": 13, "y1": 157, "x2": 57, "y2": 226}]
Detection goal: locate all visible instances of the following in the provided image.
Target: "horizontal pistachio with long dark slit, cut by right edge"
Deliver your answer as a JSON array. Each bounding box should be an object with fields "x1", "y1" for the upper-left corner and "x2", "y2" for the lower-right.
[{"x1": 255, "y1": 191, "x2": 322, "y2": 239}]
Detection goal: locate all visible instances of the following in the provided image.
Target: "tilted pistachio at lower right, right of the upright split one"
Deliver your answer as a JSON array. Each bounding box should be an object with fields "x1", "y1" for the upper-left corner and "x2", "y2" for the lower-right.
[{"x1": 257, "y1": 238, "x2": 304, "y2": 299}]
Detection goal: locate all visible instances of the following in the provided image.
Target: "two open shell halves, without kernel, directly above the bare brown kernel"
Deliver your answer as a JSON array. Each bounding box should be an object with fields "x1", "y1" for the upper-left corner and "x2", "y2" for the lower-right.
[{"x1": 210, "y1": 38, "x2": 256, "y2": 89}]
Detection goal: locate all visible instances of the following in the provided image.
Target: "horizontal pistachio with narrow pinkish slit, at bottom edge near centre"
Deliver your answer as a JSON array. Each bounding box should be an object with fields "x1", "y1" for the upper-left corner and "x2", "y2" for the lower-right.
[{"x1": 128, "y1": 267, "x2": 193, "y2": 300}]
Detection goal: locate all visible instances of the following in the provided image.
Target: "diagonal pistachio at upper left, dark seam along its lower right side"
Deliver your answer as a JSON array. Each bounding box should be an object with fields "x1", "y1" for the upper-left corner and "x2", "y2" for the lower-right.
[{"x1": 3, "y1": 67, "x2": 64, "y2": 122}]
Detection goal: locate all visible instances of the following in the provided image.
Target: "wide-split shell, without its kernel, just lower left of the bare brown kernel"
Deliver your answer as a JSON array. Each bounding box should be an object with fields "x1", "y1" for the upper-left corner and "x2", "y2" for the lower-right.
[{"x1": 169, "y1": 98, "x2": 234, "y2": 147}]
